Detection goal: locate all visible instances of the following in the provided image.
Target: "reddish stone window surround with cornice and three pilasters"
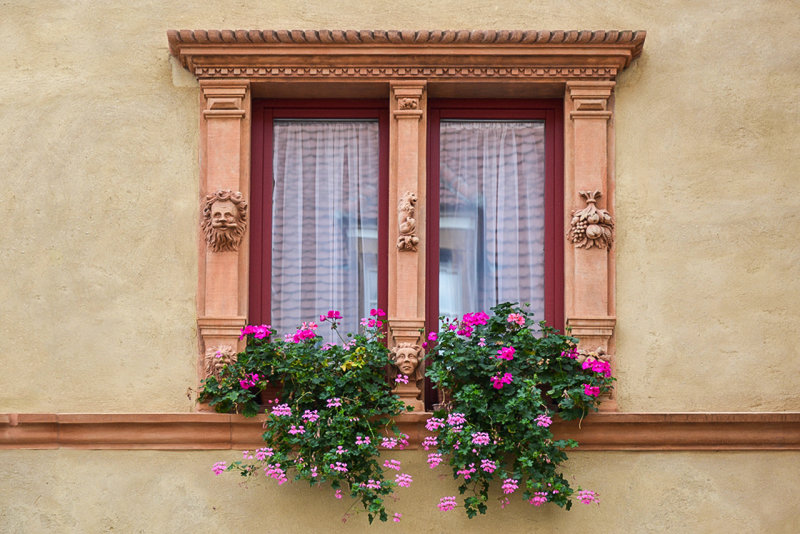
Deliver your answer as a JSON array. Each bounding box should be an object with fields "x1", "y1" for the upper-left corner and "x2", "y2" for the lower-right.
[{"x1": 168, "y1": 30, "x2": 645, "y2": 410}]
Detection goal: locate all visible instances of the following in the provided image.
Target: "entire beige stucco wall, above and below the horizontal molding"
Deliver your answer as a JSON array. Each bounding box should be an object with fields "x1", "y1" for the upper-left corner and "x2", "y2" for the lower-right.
[{"x1": 0, "y1": 0, "x2": 800, "y2": 532}]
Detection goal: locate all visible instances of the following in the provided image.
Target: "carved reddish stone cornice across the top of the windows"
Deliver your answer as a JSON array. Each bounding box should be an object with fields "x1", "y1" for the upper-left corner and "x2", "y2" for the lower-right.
[{"x1": 167, "y1": 30, "x2": 646, "y2": 80}]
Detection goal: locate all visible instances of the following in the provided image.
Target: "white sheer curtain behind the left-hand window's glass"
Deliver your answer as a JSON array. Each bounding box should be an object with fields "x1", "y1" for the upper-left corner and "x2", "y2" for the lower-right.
[{"x1": 272, "y1": 120, "x2": 379, "y2": 341}]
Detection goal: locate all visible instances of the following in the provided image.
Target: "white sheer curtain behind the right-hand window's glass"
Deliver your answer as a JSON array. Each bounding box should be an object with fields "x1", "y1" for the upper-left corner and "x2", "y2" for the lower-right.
[{"x1": 439, "y1": 120, "x2": 545, "y2": 320}]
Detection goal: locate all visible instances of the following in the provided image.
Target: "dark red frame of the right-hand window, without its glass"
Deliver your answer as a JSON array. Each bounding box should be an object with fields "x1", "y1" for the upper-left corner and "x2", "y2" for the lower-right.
[{"x1": 425, "y1": 99, "x2": 564, "y2": 408}]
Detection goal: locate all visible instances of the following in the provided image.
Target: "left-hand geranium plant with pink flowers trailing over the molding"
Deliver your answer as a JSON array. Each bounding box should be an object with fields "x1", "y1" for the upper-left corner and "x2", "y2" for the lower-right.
[{"x1": 200, "y1": 310, "x2": 411, "y2": 522}]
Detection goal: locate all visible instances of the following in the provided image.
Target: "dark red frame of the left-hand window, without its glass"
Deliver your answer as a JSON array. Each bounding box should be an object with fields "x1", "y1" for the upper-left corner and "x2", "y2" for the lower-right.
[{"x1": 248, "y1": 99, "x2": 389, "y2": 324}]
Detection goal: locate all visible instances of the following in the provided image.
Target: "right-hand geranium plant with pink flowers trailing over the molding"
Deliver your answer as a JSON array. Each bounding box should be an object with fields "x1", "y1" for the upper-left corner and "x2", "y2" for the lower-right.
[{"x1": 423, "y1": 303, "x2": 613, "y2": 517}]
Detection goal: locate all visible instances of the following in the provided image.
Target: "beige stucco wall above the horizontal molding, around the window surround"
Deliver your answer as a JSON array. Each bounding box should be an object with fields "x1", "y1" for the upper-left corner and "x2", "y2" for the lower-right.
[{"x1": 0, "y1": 0, "x2": 800, "y2": 412}]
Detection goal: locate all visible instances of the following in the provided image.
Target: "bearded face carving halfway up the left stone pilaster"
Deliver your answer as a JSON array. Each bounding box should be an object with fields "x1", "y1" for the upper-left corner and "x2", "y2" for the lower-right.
[{"x1": 201, "y1": 190, "x2": 247, "y2": 252}]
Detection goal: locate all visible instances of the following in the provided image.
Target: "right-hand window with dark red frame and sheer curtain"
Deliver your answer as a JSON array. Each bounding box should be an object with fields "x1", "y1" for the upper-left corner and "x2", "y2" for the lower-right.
[{"x1": 426, "y1": 99, "x2": 563, "y2": 329}]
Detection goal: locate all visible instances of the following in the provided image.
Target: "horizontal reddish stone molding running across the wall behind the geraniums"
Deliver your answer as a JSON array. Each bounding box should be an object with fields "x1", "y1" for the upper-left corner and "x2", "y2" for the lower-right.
[{"x1": 0, "y1": 412, "x2": 800, "y2": 451}]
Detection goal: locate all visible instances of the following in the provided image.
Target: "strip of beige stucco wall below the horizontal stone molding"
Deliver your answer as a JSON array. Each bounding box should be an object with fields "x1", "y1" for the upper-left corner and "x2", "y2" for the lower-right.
[{"x1": 0, "y1": 451, "x2": 800, "y2": 534}]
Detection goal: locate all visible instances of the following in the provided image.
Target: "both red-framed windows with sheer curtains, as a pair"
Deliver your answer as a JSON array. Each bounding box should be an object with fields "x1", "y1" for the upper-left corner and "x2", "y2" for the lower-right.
[{"x1": 249, "y1": 100, "x2": 563, "y2": 340}]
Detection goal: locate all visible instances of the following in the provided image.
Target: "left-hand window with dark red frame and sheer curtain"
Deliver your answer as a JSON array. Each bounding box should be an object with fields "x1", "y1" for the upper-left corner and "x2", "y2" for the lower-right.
[{"x1": 248, "y1": 100, "x2": 388, "y2": 341}]
